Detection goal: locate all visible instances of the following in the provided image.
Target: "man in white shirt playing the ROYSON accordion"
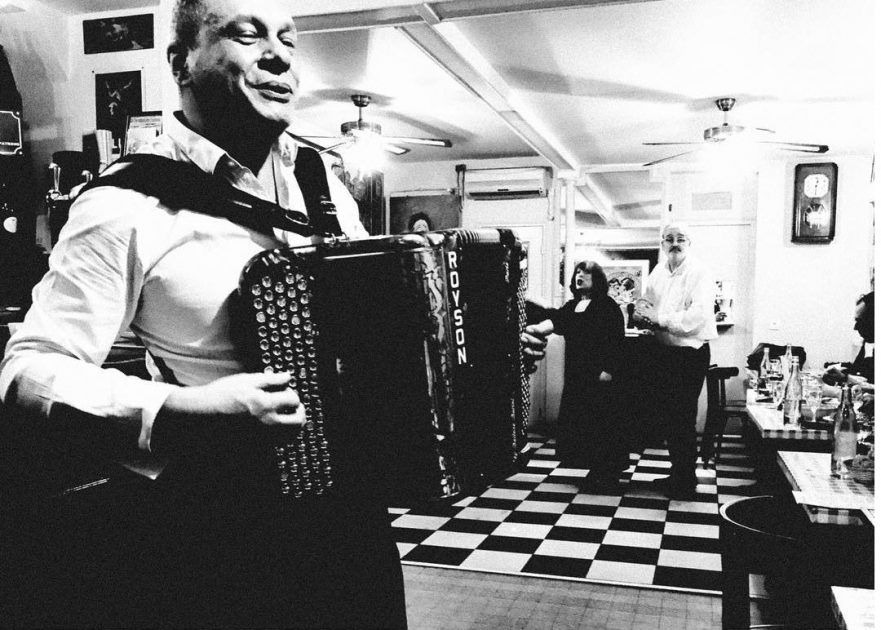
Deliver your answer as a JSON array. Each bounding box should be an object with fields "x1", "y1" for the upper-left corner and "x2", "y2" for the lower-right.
[{"x1": 0, "y1": 0, "x2": 406, "y2": 629}]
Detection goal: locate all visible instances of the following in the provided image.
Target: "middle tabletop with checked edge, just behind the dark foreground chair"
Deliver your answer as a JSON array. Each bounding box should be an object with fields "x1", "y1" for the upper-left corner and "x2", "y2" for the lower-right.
[{"x1": 777, "y1": 451, "x2": 875, "y2": 525}]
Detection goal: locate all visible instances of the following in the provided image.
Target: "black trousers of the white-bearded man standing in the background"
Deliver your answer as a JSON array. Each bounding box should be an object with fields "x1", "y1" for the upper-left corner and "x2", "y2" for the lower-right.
[{"x1": 658, "y1": 343, "x2": 710, "y2": 484}]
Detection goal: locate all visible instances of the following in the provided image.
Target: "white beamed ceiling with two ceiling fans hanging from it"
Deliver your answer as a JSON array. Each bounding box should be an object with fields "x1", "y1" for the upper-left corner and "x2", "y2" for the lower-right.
[{"x1": 18, "y1": 0, "x2": 876, "y2": 222}]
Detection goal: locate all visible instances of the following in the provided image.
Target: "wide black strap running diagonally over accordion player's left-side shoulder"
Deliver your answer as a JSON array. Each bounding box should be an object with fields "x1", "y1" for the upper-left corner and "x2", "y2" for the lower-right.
[{"x1": 78, "y1": 153, "x2": 312, "y2": 236}]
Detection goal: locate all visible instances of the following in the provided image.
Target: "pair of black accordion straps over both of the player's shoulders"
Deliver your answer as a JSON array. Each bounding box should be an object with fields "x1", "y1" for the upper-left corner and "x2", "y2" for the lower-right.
[{"x1": 83, "y1": 148, "x2": 341, "y2": 236}]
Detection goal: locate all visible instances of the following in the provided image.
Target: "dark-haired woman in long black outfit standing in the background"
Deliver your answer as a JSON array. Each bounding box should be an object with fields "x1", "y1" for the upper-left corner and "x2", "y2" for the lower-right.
[{"x1": 541, "y1": 261, "x2": 629, "y2": 486}]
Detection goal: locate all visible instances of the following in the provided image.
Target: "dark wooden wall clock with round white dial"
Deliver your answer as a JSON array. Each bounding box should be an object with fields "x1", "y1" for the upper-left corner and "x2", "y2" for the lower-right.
[{"x1": 792, "y1": 162, "x2": 838, "y2": 243}]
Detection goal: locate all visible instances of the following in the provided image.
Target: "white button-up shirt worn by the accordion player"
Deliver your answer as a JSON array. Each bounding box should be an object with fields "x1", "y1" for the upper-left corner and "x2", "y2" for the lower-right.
[{"x1": 0, "y1": 112, "x2": 367, "y2": 449}]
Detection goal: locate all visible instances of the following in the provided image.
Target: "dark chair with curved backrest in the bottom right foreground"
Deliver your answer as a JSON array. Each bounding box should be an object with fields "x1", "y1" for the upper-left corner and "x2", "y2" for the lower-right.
[{"x1": 719, "y1": 496, "x2": 834, "y2": 630}]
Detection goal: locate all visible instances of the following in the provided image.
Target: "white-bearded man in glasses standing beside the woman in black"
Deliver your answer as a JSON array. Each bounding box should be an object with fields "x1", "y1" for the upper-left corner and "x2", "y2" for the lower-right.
[{"x1": 636, "y1": 223, "x2": 718, "y2": 499}]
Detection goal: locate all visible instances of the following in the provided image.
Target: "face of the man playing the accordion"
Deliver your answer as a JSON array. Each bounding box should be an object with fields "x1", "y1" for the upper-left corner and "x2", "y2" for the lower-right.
[{"x1": 187, "y1": 0, "x2": 300, "y2": 130}]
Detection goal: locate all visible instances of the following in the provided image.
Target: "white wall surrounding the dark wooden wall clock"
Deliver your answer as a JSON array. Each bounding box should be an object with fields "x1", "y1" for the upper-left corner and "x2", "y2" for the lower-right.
[{"x1": 753, "y1": 155, "x2": 874, "y2": 367}]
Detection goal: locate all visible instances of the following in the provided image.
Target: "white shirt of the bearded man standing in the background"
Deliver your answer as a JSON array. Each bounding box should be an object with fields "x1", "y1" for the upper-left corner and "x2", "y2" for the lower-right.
[{"x1": 646, "y1": 256, "x2": 719, "y2": 348}]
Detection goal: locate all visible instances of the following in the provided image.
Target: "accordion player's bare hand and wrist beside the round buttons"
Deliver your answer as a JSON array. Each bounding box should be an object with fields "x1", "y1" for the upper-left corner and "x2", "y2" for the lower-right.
[{"x1": 160, "y1": 372, "x2": 306, "y2": 427}]
